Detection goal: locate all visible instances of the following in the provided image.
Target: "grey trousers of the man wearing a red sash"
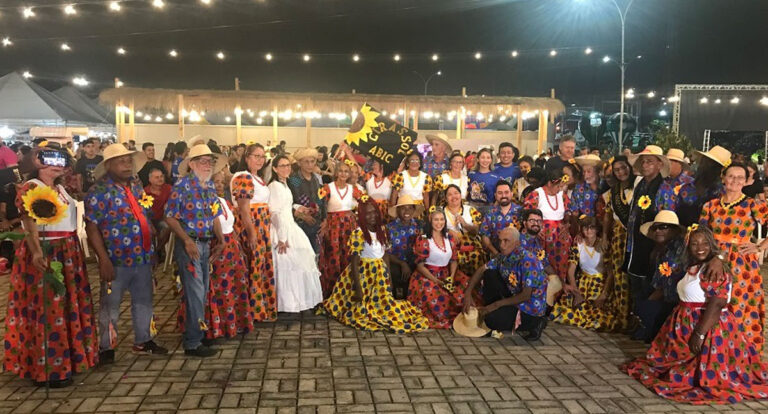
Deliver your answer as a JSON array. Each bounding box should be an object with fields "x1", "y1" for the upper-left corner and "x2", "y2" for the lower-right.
[{"x1": 99, "y1": 264, "x2": 154, "y2": 351}]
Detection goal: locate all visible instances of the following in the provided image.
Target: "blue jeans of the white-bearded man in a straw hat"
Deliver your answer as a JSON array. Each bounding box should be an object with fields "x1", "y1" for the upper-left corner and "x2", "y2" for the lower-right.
[{"x1": 173, "y1": 241, "x2": 211, "y2": 350}]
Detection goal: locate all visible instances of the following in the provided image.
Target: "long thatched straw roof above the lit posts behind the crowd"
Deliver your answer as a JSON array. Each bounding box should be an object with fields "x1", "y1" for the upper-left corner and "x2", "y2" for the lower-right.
[{"x1": 99, "y1": 87, "x2": 565, "y2": 115}]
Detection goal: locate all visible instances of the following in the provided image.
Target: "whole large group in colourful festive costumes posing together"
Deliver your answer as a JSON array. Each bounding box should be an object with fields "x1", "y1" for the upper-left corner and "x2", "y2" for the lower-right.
[{"x1": 0, "y1": 134, "x2": 768, "y2": 403}]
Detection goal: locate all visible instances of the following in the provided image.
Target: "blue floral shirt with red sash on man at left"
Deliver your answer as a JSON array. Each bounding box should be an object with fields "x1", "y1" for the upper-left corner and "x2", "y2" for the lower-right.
[{"x1": 84, "y1": 175, "x2": 154, "y2": 267}]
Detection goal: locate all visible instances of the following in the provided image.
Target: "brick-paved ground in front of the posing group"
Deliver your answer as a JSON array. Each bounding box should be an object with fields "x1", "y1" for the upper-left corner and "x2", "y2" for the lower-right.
[{"x1": 0, "y1": 267, "x2": 768, "y2": 413}]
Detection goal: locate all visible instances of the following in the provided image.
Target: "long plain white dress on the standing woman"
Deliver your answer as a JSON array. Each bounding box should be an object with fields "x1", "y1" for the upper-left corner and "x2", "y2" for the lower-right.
[{"x1": 269, "y1": 181, "x2": 323, "y2": 312}]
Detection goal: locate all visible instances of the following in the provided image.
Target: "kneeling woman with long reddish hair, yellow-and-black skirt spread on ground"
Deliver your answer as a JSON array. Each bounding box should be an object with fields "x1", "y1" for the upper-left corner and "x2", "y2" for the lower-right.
[{"x1": 323, "y1": 196, "x2": 429, "y2": 333}]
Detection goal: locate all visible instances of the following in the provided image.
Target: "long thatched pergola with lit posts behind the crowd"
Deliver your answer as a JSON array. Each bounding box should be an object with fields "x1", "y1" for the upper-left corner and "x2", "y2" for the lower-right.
[{"x1": 99, "y1": 80, "x2": 565, "y2": 152}]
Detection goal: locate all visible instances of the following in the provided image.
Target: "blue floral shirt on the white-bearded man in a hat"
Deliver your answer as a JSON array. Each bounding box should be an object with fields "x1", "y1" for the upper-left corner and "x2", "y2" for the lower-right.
[{"x1": 165, "y1": 173, "x2": 222, "y2": 239}]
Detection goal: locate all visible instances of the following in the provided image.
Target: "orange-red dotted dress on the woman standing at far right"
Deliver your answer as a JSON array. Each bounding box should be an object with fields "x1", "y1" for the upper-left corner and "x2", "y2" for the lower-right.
[{"x1": 699, "y1": 197, "x2": 768, "y2": 352}]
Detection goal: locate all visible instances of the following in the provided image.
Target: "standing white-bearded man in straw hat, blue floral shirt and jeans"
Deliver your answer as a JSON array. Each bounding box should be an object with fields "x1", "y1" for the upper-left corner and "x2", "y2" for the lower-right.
[{"x1": 165, "y1": 145, "x2": 227, "y2": 358}]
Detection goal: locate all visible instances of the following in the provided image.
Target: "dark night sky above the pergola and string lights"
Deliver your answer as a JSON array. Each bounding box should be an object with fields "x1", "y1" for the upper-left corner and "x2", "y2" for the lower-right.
[{"x1": 0, "y1": 0, "x2": 768, "y2": 106}]
